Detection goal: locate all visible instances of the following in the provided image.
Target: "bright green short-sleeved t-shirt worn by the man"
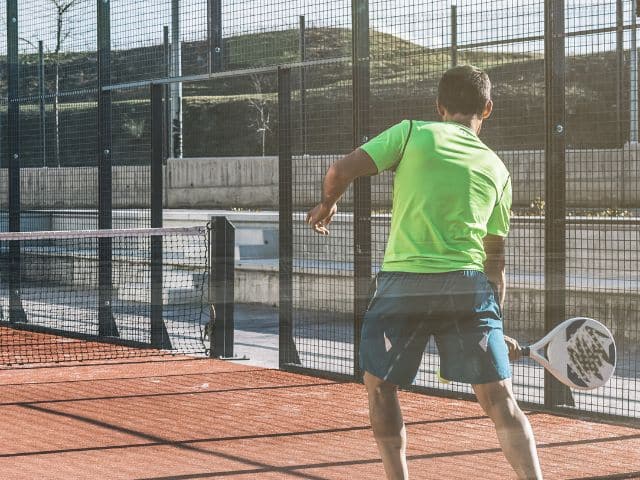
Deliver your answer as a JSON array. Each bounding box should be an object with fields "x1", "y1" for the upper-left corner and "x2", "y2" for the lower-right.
[{"x1": 361, "y1": 120, "x2": 511, "y2": 273}]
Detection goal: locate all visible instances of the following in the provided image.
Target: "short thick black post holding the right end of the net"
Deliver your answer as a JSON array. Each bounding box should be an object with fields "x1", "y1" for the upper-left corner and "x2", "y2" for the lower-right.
[{"x1": 209, "y1": 216, "x2": 235, "y2": 358}]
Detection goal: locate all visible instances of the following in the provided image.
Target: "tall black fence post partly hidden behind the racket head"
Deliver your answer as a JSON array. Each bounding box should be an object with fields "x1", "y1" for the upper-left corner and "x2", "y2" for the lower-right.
[{"x1": 544, "y1": 0, "x2": 573, "y2": 408}]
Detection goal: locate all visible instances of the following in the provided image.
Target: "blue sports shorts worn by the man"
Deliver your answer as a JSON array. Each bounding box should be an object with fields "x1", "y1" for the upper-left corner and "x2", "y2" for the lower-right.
[{"x1": 360, "y1": 270, "x2": 511, "y2": 385}]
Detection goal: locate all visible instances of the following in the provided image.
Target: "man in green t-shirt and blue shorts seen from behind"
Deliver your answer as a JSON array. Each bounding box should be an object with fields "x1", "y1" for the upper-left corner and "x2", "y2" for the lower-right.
[{"x1": 307, "y1": 66, "x2": 542, "y2": 480}]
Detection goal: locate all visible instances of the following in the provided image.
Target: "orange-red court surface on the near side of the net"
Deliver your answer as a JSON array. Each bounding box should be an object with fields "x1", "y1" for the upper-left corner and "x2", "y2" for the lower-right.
[{"x1": 0, "y1": 356, "x2": 640, "y2": 480}]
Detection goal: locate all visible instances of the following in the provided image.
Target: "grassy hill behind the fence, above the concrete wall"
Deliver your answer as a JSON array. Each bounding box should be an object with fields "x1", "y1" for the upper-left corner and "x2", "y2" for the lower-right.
[{"x1": 0, "y1": 28, "x2": 628, "y2": 165}]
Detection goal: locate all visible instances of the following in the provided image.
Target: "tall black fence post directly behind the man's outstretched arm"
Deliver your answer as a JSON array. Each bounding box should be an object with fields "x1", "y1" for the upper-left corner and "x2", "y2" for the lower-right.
[{"x1": 352, "y1": 0, "x2": 371, "y2": 377}]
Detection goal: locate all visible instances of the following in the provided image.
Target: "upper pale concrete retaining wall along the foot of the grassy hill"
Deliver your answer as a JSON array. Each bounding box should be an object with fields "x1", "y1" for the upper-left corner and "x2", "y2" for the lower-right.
[{"x1": 0, "y1": 146, "x2": 640, "y2": 209}]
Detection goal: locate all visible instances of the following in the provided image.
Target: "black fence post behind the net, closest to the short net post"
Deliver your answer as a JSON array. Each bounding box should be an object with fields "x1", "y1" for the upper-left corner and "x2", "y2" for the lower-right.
[{"x1": 151, "y1": 84, "x2": 172, "y2": 350}]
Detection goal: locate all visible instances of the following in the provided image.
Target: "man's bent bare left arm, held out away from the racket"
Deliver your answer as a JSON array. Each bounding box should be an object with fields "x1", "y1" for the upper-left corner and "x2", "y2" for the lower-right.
[{"x1": 307, "y1": 148, "x2": 378, "y2": 235}]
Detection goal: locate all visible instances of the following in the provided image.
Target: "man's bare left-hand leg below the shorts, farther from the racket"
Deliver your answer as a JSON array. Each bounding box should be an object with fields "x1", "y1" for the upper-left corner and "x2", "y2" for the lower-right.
[{"x1": 364, "y1": 372, "x2": 409, "y2": 480}]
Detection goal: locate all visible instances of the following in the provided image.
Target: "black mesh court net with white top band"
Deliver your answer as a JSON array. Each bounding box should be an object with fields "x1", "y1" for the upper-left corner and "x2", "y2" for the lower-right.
[{"x1": 0, "y1": 227, "x2": 210, "y2": 367}]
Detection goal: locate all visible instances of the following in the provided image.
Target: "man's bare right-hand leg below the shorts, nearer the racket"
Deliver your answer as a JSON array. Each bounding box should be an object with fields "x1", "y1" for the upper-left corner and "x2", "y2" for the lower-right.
[{"x1": 473, "y1": 379, "x2": 542, "y2": 480}]
